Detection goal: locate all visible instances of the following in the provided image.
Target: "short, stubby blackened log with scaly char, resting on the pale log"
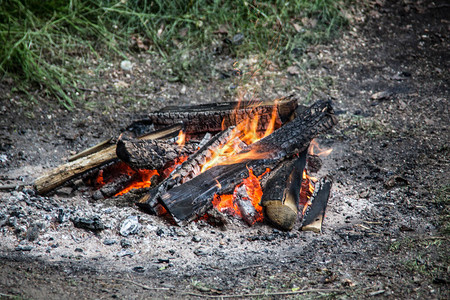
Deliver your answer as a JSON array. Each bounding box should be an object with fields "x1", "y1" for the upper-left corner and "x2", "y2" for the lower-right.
[{"x1": 116, "y1": 136, "x2": 198, "y2": 170}]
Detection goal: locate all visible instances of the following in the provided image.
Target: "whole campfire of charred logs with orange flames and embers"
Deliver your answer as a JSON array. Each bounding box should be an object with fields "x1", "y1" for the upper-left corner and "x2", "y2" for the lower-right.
[{"x1": 35, "y1": 97, "x2": 336, "y2": 231}]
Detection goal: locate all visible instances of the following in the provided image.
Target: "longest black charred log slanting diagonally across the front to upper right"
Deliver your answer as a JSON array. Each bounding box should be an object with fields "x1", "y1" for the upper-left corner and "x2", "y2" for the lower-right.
[{"x1": 159, "y1": 101, "x2": 337, "y2": 225}]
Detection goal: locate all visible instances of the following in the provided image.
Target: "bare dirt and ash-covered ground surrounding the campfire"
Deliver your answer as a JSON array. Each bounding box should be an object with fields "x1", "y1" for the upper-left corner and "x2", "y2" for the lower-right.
[{"x1": 0, "y1": 0, "x2": 450, "y2": 299}]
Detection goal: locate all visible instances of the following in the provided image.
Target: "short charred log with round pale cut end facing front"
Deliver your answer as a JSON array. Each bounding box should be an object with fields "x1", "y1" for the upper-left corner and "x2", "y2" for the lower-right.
[{"x1": 261, "y1": 150, "x2": 307, "y2": 230}]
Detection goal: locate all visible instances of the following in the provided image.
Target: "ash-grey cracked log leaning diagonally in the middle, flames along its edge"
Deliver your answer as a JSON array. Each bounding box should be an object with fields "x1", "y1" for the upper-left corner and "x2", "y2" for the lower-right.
[{"x1": 137, "y1": 127, "x2": 241, "y2": 214}]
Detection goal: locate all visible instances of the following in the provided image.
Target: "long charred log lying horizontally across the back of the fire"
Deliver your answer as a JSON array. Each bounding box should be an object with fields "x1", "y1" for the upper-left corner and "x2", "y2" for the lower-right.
[{"x1": 131, "y1": 96, "x2": 298, "y2": 133}]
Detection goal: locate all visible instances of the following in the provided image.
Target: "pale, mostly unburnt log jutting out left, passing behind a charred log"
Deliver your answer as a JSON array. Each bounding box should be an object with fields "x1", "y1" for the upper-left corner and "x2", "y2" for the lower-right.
[{"x1": 34, "y1": 124, "x2": 182, "y2": 194}]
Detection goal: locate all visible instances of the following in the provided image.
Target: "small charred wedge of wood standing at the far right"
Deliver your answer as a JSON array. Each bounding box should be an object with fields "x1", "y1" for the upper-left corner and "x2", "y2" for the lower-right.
[{"x1": 301, "y1": 176, "x2": 333, "y2": 233}]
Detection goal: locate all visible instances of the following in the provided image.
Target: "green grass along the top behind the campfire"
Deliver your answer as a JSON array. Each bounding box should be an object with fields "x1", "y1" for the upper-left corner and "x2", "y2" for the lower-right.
[{"x1": 0, "y1": 0, "x2": 350, "y2": 109}]
